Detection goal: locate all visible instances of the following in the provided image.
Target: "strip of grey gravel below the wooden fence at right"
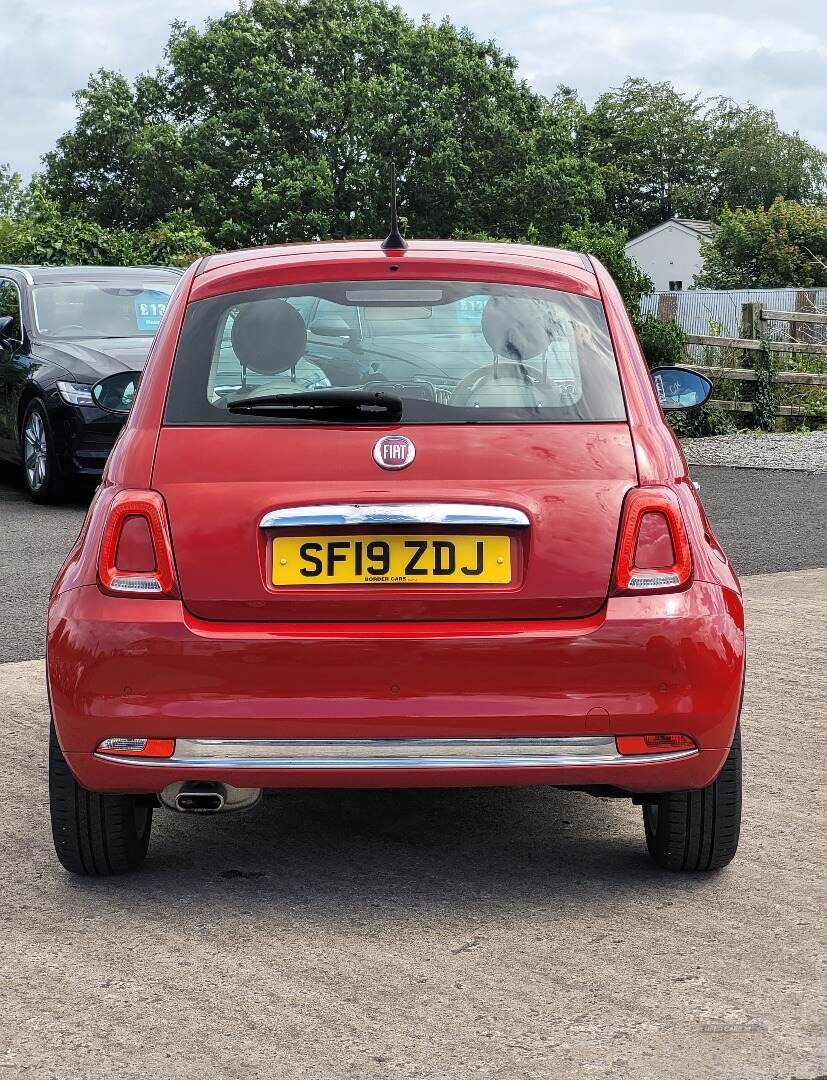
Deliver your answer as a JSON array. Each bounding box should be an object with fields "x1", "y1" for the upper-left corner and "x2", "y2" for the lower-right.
[{"x1": 681, "y1": 431, "x2": 827, "y2": 472}]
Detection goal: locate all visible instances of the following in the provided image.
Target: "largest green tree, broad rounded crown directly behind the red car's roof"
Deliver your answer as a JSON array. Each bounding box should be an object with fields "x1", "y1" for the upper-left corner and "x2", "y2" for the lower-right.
[{"x1": 46, "y1": 0, "x2": 604, "y2": 246}]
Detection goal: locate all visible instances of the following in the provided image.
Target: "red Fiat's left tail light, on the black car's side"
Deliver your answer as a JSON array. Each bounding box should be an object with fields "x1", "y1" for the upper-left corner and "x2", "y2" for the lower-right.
[{"x1": 97, "y1": 491, "x2": 178, "y2": 597}]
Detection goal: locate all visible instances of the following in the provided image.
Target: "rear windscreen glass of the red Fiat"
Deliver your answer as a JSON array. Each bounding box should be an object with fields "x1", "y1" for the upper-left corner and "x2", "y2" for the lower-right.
[{"x1": 165, "y1": 281, "x2": 625, "y2": 426}]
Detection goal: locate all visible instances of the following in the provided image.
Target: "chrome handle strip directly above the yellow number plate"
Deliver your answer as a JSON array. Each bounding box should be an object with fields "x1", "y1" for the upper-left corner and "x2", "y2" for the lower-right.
[{"x1": 258, "y1": 502, "x2": 529, "y2": 529}]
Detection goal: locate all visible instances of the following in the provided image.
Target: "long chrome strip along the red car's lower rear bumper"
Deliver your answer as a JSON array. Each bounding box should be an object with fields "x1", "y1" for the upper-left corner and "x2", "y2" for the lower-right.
[{"x1": 95, "y1": 735, "x2": 697, "y2": 769}]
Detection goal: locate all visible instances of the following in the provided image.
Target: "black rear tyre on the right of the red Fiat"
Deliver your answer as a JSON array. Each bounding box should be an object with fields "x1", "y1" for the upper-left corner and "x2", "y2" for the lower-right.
[{"x1": 643, "y1": 725, "x2": 741, "y2": 870}]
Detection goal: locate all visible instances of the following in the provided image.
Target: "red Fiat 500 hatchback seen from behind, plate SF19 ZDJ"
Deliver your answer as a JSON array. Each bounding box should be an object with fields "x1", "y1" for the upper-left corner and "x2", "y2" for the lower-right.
[{"x1": 49, "y1": 241, "x2": 744, "y2": 874}]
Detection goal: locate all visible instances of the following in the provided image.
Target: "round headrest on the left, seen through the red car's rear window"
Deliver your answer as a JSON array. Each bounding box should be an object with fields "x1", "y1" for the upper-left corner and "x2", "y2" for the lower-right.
[{"x1": 231, "y1": 298, "x2": 308, "y2": 375}]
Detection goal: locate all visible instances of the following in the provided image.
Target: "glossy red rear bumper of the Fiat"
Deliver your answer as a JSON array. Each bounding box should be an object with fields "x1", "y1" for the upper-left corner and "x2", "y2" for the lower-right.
[{"x1": 49, "y1": 582, "x2": 744, "y2": 792}]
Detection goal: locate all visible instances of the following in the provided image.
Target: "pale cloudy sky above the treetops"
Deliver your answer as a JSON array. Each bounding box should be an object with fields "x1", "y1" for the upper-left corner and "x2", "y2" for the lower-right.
[{"x1": 0, "y1": 0, "x2": 827, "y2": 178}]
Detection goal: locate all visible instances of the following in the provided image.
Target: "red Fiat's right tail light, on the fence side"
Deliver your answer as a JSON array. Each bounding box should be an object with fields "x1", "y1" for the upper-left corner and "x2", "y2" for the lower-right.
[{"x1": 614, "y1": 487, "x2": 692, "y2": 593}]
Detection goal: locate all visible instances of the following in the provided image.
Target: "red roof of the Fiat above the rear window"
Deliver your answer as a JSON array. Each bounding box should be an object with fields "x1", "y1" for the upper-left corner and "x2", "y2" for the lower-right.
[{"x1": 190, "y1": 240, "x2": 600, "y2": 301}]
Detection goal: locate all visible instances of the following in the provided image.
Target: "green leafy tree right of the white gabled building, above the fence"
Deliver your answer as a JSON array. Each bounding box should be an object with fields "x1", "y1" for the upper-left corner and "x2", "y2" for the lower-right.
[{"x1": 696, "y1": 199, "x2": 827, "y2": 288}]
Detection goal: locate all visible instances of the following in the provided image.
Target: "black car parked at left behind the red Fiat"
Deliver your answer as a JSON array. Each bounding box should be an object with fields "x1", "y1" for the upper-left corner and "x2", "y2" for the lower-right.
[{"x1": 0, "y1": 266, "x2": 180, "y2": 502}]
